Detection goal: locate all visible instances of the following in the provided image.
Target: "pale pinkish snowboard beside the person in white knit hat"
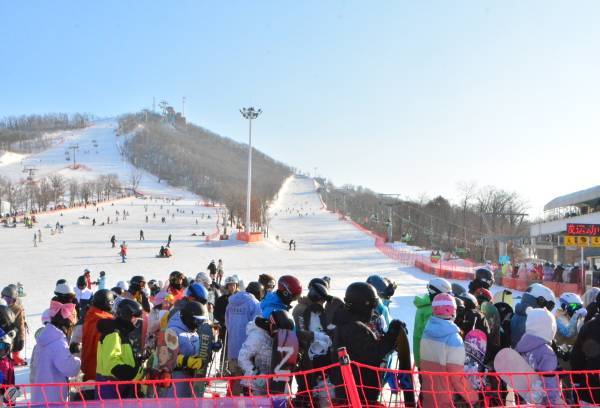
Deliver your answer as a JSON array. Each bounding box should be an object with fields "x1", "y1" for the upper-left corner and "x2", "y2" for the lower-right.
[{"x1": 494, "y1": 348, "x2": 566, "y2": 406}]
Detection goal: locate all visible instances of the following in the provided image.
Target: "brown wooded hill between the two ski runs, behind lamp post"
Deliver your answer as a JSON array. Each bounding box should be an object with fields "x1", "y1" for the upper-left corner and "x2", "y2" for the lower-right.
[{"x1": 119, "y1": 112, "x2": 292, "y2": 230}]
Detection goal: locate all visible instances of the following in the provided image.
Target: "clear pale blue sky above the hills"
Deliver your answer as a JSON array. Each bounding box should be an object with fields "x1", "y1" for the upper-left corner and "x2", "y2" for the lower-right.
[{"x1": 0, "y1": 0, "x2": 600, "y2": 215}]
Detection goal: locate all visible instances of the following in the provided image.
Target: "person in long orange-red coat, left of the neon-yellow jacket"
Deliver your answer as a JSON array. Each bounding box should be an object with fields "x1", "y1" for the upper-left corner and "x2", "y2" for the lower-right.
[{"x1": 81, "y1": 289, "x2": 114, "y2": 381}]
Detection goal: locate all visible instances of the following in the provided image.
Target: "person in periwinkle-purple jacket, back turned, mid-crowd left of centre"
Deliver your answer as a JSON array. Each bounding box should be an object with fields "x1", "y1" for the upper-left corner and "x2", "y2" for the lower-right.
[{"x1": 225, "y1": 282, "x2": 261, "y2": 395}]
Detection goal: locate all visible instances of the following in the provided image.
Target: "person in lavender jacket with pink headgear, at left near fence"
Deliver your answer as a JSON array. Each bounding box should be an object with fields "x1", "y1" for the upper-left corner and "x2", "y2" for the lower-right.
[{"x1": 29, "y1": 300, "x2": 81, "y2": 404}]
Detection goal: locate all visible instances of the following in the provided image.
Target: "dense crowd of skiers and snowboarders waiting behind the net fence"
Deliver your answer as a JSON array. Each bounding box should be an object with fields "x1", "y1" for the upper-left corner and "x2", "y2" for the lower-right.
[{"x1": 0, "y1": 260, "x2": 600, "y2": 407}]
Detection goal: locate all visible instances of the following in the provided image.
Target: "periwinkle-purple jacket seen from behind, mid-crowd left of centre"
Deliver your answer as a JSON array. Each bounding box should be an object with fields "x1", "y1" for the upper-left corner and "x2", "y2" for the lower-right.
[{"x1": 225, "y1": 292, "x2": 261, "y2": 359}]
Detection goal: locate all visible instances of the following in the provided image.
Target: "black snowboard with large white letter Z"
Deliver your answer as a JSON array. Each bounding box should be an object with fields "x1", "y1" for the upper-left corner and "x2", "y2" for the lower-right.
[{"x1": 269, "y1": 329, "x2": 299, "y2": 394}]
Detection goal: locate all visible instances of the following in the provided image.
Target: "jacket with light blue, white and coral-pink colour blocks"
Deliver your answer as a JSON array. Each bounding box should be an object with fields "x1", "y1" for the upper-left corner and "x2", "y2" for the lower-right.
[{"x1": 419, "y1": 316, "x2": 478, "y2": 407}]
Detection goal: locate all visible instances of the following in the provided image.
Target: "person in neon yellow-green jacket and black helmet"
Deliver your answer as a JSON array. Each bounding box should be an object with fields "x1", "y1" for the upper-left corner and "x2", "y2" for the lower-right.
[{"x1": 96, "y1": 299, "x2": 145, "y2": 399}]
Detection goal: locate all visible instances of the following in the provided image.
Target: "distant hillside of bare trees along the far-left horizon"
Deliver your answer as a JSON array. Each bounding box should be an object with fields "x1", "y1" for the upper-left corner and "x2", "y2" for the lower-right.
[{"x1": 0, "y1": 113, "x2": 90, "y2": 153}]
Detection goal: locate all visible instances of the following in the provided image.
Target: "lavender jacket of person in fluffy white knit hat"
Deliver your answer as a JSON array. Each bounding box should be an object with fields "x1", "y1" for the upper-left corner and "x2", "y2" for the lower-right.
[{"x1": 515, "y1": 333, "x2": 561, "y2": 404}]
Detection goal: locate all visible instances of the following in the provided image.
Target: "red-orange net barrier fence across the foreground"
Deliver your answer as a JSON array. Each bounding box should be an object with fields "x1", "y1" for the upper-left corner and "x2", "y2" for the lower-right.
[{"x1": 5, "y1": 348, "x2": 600, "y2": 408}]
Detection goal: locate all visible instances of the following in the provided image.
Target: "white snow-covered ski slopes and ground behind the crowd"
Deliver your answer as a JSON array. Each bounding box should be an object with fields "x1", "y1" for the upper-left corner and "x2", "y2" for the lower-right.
[{"x1": 0, "y1": 121, "x2": 516, "y2": 382}]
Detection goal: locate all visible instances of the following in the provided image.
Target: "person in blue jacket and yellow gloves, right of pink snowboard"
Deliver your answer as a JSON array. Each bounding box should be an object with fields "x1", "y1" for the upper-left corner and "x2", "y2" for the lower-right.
[{"x1": 168, "y1": 301, "x2": 207, "y2": 398}]
